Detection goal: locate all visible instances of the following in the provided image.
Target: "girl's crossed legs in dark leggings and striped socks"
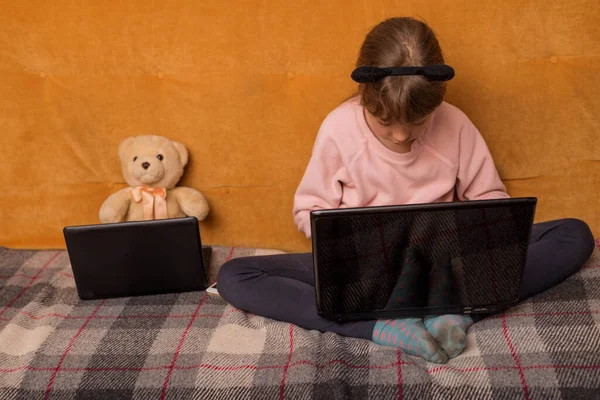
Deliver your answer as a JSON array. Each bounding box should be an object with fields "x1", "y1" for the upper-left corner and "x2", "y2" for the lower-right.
[{"x1": 218, "y1": 219, "x2": 595, "y2": 362}]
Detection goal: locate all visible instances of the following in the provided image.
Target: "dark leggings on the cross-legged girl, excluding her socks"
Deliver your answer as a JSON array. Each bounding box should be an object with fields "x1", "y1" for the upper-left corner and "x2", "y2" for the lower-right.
[{"x1": 218, "y1": 219, "x2": 594, "y2": 339}]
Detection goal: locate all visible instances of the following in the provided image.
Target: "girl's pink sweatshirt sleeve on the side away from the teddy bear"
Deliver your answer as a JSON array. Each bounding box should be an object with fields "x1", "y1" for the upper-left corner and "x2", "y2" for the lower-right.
[{"x1": 456, "y1": 122, "x2": 510, "y2": 201}]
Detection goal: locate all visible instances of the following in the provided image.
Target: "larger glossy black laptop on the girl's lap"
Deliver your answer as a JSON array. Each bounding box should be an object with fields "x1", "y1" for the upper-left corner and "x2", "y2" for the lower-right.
[{"x1": 310, "y1": 198, "x2": 537, "y2": 322}]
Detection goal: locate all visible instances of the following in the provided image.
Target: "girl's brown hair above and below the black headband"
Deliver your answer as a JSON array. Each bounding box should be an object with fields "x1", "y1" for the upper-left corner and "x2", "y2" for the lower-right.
[{"x1": 356, "y1": 17, "x2": 446, "y2": 123}]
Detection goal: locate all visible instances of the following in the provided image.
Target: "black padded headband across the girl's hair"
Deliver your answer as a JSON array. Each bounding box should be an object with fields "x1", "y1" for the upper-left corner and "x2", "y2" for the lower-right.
[{"x1": 351, "y1": 64, "x2": 454, "y2": 83}]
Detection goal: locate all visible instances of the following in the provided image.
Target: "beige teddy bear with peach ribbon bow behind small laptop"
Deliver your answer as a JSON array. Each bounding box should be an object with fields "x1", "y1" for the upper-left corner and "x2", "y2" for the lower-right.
[{"x1": 100, "y1": 135, "x2": 209, "y2": 223}]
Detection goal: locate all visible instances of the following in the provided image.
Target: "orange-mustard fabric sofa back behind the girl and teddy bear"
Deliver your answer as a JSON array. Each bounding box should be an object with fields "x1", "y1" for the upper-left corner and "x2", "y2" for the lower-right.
[{"x1": 0, "y1": 0, "x2": 600, "y2": 250}]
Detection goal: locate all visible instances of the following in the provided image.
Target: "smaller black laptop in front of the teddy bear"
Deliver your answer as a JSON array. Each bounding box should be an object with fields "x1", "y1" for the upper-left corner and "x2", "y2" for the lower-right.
[{"x1": 63, "y1": 217, "x2": 211, "y2": 300}]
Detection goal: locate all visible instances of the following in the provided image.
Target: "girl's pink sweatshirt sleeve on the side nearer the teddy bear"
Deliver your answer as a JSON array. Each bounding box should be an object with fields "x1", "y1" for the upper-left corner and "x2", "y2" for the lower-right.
[{"x1": 293, "y1": 121, "x2": 347, "y2": 238}]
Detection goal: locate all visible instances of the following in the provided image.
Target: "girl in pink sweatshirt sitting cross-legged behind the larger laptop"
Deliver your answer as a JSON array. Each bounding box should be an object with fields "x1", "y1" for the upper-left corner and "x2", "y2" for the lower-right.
[{"x1": 218, "y1": 18, "x2": 594, "y2": 363}]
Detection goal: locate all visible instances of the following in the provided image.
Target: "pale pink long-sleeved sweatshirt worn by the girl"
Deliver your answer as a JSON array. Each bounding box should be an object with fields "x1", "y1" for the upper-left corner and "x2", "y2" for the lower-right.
[{"x1": 293, "y1": 98, "x2": 509, "y2": 237}]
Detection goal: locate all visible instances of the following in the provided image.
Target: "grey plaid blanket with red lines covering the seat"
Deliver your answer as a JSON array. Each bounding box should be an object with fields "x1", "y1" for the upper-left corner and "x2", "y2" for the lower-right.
[{"x1": 0, "y1": 242, "x2": 600, "y2": 400}]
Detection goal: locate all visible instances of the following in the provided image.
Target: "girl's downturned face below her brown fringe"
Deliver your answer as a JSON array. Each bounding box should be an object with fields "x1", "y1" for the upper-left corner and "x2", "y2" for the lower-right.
[{"x1": 364, "y1": 109, "x2": 431, "y2": 153}]
